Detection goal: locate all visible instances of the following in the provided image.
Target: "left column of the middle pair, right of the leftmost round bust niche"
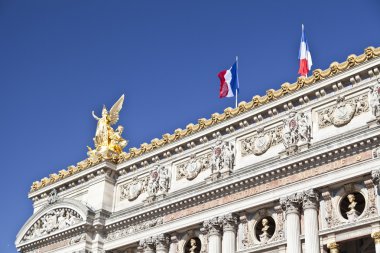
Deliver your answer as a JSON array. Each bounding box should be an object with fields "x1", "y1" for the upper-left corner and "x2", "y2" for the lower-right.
[{"x1": 203, "y1": 218, "x2": 222, "y2": 253}]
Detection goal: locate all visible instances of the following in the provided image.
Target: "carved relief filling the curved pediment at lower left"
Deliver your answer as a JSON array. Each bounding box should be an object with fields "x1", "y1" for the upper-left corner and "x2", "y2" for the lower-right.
[{"x1": 22, "y1": 208, "x2": 83, "y2": 242}]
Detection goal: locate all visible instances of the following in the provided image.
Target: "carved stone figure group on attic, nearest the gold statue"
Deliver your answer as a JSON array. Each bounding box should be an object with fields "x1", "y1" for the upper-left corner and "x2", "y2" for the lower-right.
[{"x1": 147, "y1": 164, "x2": 170, "y2": 196}]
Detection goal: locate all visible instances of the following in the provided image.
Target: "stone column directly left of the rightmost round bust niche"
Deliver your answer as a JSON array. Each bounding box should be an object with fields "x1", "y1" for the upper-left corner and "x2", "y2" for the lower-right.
[{"x1": 302, "y1": 189, "x2": 320, "y2": 253}]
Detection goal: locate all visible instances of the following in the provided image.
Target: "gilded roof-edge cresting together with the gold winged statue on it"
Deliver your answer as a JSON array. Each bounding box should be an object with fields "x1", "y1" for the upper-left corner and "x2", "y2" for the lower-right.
[{"x1": 30, "y1": 47, "x2": 380, "y2": 192}]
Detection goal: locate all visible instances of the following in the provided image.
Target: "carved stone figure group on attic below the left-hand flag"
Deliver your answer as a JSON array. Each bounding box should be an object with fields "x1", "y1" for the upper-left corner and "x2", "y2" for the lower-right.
[{"x1": 211, "y1": 137, "x2": 235, "y2": 173}]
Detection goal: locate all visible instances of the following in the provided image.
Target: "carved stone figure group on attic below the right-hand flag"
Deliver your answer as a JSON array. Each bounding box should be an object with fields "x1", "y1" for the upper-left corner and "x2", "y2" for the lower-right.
[{"x1": 282, "y1": 111, "x2": 311, "y2": 149}]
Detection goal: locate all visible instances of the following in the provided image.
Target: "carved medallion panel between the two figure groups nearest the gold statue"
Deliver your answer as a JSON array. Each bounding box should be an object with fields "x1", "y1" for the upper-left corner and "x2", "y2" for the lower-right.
[{"x1": 176, "y1": 153, "x2": 211, "y2": 180}]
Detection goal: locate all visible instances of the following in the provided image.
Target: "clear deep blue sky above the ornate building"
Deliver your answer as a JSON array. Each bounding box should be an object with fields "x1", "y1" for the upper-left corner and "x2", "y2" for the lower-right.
[{"x1": 0, "y1": 0, "x2": 380, "y2": 253}]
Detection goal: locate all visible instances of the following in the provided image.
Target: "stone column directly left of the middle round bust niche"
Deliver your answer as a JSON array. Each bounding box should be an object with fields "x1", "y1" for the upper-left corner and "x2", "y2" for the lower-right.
[{"x1": 221, "y1": 214, "x2": 237, "y2": 253}]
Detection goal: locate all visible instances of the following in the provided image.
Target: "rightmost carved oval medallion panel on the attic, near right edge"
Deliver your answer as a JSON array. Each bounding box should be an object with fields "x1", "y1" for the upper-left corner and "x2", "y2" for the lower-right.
[{"x1": 318, "y1": 94, "x2": 369, "y2": 129}]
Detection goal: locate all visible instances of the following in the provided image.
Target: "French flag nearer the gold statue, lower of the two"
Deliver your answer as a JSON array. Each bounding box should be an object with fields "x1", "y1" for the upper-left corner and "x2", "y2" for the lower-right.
[{"x1": 218, "y1": 59, "x2": 239, "y2": 98}]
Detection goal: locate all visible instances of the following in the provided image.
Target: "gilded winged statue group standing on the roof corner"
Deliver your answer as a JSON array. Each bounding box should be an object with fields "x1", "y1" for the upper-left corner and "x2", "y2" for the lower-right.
[{"x1": 87, "y1": 94, "x2": 128, "y2": 159}]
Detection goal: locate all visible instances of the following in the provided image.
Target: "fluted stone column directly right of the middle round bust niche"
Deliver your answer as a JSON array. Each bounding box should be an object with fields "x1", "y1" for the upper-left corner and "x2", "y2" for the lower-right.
[{"x1": 280, "y1": 193, "x2": 302, "y2": 253}]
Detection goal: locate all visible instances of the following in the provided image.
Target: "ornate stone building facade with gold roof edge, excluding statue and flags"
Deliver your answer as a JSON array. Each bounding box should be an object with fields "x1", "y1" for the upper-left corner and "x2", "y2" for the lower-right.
[{"x1": 16, "y1": 47, "x2": 380, "y2": 253}]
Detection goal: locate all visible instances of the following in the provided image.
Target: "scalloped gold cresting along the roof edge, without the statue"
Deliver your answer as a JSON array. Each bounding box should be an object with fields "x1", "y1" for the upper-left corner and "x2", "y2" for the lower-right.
[{"x1": 30, "y1": 47, "x2": 380, "y2": 192}]
